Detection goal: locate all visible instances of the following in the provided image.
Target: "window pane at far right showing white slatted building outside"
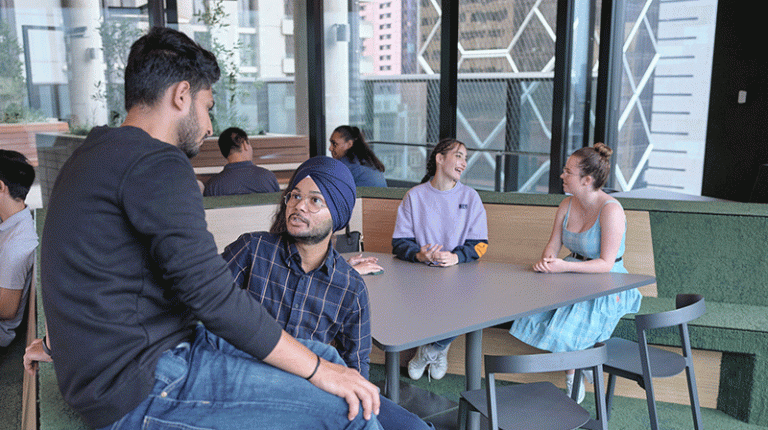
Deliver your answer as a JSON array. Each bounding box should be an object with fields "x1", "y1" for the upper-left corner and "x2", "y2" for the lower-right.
[{"x1": 611, "y1": 0, "x2": 717, "y2": 195}]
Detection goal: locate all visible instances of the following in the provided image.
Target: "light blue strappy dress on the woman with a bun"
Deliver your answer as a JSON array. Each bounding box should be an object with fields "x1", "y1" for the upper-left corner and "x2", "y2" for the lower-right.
[{"x1": 509, "y1": 200, "x2": 642, "y2": 352}]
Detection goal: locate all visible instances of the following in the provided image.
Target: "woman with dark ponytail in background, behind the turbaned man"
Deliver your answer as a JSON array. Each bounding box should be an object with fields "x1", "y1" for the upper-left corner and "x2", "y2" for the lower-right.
[{"x1": 330, "y1": 125, "x2": 387, "y2": 187}]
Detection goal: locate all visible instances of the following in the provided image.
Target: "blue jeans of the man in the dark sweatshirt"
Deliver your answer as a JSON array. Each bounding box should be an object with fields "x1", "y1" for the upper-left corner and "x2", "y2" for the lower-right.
[{"x1": 99, "y1": 325, "x2": 381, "y2": 430}]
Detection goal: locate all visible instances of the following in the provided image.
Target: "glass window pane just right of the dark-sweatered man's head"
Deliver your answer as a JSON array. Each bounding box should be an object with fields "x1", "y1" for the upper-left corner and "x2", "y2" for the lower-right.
[{"x1": 186, "y1": 0, "x2": 296, "y2": 134}]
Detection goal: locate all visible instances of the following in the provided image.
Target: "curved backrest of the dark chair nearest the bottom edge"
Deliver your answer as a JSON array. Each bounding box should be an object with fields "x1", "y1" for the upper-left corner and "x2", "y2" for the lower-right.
[{"x1": 485, "y1": 343, "x2": 608, "y2": 377}]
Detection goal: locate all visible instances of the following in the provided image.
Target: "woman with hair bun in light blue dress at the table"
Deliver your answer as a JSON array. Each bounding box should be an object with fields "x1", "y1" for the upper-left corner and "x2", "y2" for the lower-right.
[{"x1": 509, "y1": 143, "x2": 642, "y2": 402}]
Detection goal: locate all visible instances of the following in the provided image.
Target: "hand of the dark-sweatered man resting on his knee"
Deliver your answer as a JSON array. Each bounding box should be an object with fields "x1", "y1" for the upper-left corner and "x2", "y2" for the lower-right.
[{"x1": 309, "y1": 360, "x2": 381, "y2": 421}]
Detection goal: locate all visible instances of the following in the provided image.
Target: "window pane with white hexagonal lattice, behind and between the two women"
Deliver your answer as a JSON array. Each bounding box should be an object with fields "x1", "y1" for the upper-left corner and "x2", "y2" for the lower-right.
[{"x1": 456, "y1": 0, "x2": 557, "y2": 192}]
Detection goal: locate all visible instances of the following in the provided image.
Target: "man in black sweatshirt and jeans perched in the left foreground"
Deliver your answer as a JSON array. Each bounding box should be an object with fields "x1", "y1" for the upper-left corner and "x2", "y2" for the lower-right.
[{"x1": 41, "y1": 28, "x2": 379, "y2": 429}]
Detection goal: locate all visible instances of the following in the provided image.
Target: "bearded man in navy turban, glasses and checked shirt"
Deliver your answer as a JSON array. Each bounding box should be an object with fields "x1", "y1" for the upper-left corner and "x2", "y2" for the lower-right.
[{"x1": 222, "y1": 157, "x2": 434, "y2": 430}]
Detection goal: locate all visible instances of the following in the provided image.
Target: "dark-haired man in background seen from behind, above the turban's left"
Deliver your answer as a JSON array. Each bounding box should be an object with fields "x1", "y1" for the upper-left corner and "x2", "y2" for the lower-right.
[{"x1": 203, "y1": 127, "x2": 280, "y2": 196}]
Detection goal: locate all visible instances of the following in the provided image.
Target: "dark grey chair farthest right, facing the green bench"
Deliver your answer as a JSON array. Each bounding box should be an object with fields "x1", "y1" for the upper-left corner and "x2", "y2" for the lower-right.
[{"x1": 604, "y1": 294, "x2": 705, "y2": 430}]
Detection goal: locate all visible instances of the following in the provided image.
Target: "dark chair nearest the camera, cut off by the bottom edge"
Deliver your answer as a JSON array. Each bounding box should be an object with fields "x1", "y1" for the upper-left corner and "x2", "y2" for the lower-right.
[{"x1": 459, "y1": 343, "x2": 608, "y2": 430}]
